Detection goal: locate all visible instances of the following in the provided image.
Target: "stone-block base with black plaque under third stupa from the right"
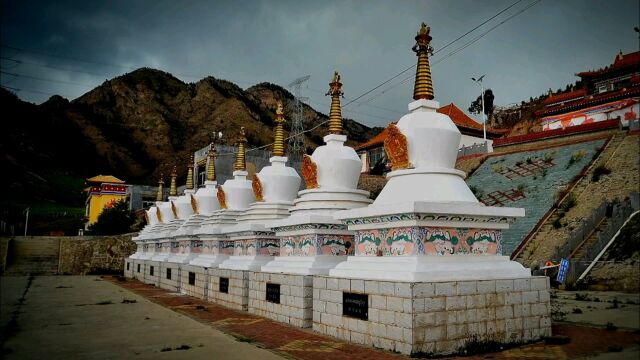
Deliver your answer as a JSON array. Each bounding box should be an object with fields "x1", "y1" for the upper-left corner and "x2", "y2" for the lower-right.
[{"x1": 207, "y1": 269, "x2": 250, "y2": 311}]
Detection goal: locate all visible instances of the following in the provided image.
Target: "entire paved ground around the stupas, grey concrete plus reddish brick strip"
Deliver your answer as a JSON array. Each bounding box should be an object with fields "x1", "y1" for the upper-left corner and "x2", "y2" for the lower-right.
[{"x1": 0, "y1": 276, "x2": 640, "y2": 360}]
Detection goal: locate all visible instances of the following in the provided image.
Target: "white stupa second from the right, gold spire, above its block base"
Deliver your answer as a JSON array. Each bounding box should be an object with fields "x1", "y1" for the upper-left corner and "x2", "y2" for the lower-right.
[{"x1": 262, "y1": 72, "x2": 372, "y2": 275}]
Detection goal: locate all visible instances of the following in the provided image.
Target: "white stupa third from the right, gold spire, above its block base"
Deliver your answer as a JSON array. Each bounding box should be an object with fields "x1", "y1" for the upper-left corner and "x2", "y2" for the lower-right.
[{"x1": 220, "y1": 103, "x2": 301, "y2": 271}]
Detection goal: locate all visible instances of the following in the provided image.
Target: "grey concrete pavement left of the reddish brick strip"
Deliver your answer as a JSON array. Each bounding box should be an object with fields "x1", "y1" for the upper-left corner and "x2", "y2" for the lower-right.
[{"x1": 0, "y1": 276, "x2": 282, "y2": 360}]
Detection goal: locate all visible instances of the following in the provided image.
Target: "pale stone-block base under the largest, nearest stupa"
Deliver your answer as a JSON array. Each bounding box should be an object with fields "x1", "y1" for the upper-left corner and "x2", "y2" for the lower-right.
[{"x1": 313, "y1": 276, "x2": 551, "y2": 354}]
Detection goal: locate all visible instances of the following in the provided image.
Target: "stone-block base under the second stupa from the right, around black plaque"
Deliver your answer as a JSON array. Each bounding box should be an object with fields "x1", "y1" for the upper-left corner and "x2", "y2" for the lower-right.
[{"x1": 249, "y1": 272, "x2": 313, "y2": 328}]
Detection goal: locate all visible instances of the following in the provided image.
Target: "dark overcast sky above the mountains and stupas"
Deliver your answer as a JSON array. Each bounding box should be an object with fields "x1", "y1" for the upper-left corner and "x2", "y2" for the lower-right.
[{"x1": 0, "y1": 0, "x2": 640, "y2": 125}]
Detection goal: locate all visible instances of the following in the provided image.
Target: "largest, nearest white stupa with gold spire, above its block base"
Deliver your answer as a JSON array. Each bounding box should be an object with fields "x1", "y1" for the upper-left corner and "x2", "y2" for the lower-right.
[{"x1": 330, "y1": 24, "x2": 531, "y2": 281}]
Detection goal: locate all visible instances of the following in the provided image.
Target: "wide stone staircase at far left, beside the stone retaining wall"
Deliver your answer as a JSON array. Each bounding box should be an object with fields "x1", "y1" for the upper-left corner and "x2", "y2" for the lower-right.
[{"x1": 4, "y1": 237, "x2": 60, "y2": 276}]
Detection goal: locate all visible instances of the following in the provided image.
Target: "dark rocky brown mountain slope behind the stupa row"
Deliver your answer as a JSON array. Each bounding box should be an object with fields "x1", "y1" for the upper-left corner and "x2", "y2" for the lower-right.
[{"x1": 0, "y1": 68, "x2": 381, "y2": 202}]
